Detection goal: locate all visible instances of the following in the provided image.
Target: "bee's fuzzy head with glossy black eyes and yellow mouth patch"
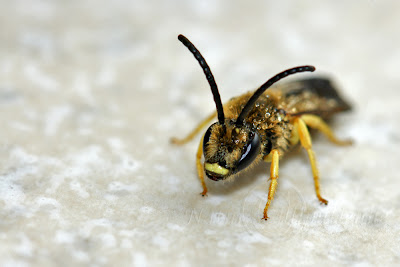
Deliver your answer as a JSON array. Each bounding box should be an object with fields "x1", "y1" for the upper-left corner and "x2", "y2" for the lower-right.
[{"x1": 203, "y1": 121, "x2": 261, "y2": 181}]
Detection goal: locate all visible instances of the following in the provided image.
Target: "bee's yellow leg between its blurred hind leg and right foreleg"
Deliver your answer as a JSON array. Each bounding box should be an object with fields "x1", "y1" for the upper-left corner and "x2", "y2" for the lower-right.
[{"x1": 294, "y1": 117, "x2": 328, "y2": 205}]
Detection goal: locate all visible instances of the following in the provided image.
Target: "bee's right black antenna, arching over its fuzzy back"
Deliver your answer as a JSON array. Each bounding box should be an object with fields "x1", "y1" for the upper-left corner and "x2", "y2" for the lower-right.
[{"x1": 236, "y1": 65, "x2": 315, "y2": 125}]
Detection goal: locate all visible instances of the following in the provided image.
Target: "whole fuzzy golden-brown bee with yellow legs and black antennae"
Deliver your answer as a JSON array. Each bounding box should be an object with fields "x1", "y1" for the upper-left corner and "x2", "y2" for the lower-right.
[{"x1": 171, "y1": 35, "x2": 352, "y2": 220}]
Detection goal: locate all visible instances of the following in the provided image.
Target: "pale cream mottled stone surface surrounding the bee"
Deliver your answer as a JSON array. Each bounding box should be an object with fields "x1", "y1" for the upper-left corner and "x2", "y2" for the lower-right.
[{"x1": 0, "y1": 0, "x2": 400, "y2": 266}]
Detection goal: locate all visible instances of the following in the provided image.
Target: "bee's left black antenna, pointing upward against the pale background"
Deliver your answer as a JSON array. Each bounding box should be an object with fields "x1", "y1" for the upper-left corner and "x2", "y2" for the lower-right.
[{"x1": 178, "y1": 34, "x2": 225, "y2": 125}]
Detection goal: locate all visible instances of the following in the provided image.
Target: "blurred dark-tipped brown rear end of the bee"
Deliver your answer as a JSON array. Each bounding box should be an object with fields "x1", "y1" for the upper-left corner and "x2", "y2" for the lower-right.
[{"x1": 277, "y1": 78, "x2": 351, "y2": 118}]
